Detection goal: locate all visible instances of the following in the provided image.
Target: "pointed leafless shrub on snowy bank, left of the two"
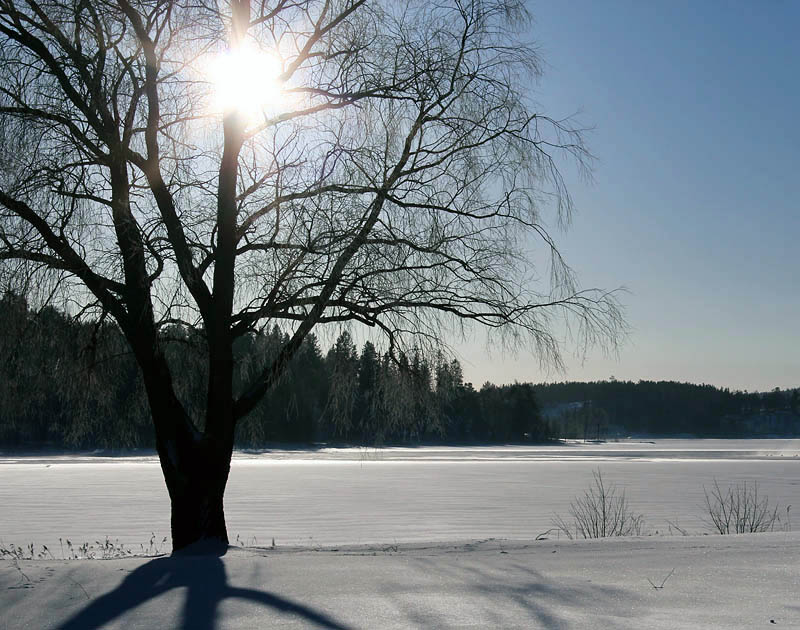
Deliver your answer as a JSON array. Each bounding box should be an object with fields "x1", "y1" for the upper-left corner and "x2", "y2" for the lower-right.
[{"x1": 553, "y1": 470, "x2": 644, "y2": 539}]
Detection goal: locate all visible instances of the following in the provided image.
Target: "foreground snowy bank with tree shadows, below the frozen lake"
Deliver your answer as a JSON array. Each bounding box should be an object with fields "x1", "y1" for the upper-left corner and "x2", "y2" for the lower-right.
[{"x1": 0, "y1": 533, "x2": 800, "y2": 630}]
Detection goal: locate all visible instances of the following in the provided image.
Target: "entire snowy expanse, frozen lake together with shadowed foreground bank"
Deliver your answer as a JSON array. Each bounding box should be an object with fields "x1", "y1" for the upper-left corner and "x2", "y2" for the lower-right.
[{"x1": 0, "y1": 440, "x2": 800, "y2": 630}]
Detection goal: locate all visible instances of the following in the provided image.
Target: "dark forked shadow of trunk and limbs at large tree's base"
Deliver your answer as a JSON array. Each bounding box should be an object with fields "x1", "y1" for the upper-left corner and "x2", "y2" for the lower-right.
[{"x1": 59, "y1": 555, "x2": 347, "y2": 630}]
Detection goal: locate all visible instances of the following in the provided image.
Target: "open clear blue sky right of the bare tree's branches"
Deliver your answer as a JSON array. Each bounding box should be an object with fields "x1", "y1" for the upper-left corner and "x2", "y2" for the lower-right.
[{"x1": 459, "y1": 0, "x2": 800, "y2": 391}]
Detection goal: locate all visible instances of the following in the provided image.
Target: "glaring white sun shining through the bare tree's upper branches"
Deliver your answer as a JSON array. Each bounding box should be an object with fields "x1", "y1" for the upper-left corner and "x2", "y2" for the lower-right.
[{"x1": 208, "y1": 42, "x2": 285, "y2": 122}]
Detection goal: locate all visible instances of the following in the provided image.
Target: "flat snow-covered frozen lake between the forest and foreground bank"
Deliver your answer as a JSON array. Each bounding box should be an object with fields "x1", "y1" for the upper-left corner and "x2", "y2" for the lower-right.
[{"x1": 0, "y1": 439, "x2": 800, "y2": 549}]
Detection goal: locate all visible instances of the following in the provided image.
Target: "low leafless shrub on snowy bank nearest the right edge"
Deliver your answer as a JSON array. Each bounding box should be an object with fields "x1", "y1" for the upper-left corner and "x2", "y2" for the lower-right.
[{"x1": 703, "y1": 479, "x2": 789, "y2": 534}]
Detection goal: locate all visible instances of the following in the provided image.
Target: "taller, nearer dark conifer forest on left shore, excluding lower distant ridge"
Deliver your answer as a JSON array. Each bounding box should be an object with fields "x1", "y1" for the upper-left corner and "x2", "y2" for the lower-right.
[{"x1": 0, "y1": 294, "x2": 553, "y2": 448}]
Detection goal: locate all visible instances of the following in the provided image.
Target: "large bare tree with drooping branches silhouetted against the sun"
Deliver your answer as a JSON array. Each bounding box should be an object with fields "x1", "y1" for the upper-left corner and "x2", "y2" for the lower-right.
[{"x1": 0, "y1": 0, "x2": 623, "y2": 549}]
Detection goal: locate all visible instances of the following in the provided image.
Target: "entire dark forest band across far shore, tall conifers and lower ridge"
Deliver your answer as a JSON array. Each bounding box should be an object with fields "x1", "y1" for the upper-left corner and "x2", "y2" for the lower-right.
[{"x1": 0, "y1": 294, "x2": 800, "y2": 449}]
